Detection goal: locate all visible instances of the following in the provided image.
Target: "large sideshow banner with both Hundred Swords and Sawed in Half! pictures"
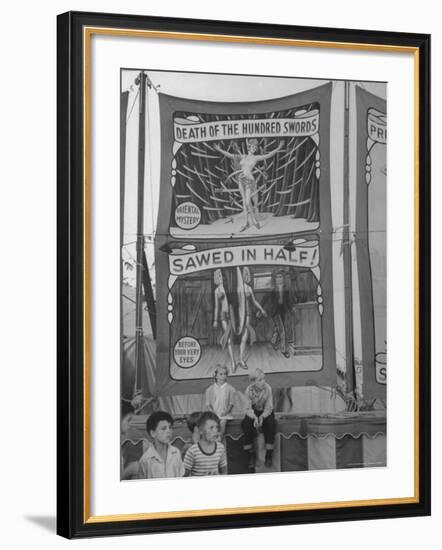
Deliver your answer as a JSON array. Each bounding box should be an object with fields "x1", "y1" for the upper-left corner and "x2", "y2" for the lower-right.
[{"x1": 155, "y1": 84, "x2": 336, "y2": 395}]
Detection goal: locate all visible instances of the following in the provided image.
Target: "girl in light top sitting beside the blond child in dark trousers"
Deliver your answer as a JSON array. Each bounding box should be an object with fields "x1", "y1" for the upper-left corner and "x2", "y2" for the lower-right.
[{"x1": 205, "y1": 365, "x2": 235, "y2": 441}]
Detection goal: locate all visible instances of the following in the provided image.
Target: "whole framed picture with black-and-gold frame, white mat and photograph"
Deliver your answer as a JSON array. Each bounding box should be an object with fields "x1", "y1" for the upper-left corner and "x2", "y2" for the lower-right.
[{"x1": 57, "y1": 12, "x2": 430, "y2": 538}]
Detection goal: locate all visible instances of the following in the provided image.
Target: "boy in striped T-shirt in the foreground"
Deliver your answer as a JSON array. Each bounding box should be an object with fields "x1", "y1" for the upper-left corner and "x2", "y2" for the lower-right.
[{"x1": 184, "y1": 411, "x2": 227, "y2": 476}]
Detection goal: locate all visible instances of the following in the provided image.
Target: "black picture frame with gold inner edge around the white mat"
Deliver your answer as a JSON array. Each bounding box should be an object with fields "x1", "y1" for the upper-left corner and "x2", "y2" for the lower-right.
[{"x1": 57, "y1": 12, "x2": 430, "y2": 538}]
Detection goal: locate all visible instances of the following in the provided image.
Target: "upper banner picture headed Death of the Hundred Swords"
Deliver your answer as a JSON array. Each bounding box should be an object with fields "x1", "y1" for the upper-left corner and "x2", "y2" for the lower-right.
[{"x1": 170, "y1": 110, "x2": 320, "y2": 239}]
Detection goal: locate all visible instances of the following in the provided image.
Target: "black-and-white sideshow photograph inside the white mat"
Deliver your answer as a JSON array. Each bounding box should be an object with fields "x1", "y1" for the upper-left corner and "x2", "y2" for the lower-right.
[{"x1": 120, "y1": 70, "x2": 388, "y2": 481}]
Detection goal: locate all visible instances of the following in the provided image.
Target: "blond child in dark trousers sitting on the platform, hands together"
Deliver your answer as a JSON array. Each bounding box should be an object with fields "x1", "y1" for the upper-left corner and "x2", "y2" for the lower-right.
[{"x1": 241, "y1": 369, "x2": 275, "y2": 472}]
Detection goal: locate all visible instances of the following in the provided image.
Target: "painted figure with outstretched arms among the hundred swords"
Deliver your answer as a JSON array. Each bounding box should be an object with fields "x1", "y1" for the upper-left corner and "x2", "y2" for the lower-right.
[{"x1": 214, "y1": 139, "x2": 283, "y2": 231}]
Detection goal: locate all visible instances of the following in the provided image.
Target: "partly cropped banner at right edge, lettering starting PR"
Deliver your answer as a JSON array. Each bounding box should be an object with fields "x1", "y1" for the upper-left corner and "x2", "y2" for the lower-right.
[{"x1": 354, "y1": 86, "x2": 387, "y2": 399}]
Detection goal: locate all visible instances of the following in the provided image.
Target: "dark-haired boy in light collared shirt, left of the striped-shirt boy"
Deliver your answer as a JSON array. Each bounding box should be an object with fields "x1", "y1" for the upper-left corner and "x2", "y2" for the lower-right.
[{"x1": 138, "y1": 411, "x2": 184, "y2": 479}]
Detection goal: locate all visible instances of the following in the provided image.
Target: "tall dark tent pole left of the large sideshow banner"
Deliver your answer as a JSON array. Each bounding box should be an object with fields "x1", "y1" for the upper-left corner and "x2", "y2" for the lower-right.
[{"x1": 134, "y1": 71, "x2": 146, "y2": 402}]
